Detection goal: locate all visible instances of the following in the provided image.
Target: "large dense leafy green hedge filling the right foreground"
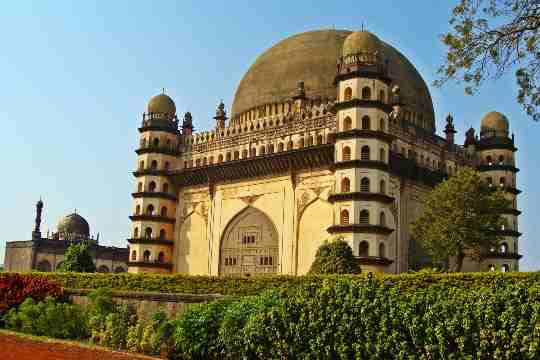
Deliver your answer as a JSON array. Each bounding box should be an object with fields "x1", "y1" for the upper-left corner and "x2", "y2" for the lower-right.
[{"x1": 171, "y1": 278, "x2": 540, "y2": 359}]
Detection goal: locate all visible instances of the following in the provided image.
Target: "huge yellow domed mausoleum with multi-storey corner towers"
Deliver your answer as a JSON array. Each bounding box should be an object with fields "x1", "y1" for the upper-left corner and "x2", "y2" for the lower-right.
[{"x1": 128, "y1": 30, "x2": 520, "y2": 276}]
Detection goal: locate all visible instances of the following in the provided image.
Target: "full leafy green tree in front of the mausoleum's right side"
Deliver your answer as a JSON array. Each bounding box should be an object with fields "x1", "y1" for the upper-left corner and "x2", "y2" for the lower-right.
[{"x1": 411, "y1": 168, "x2": 510, "y2": 271}]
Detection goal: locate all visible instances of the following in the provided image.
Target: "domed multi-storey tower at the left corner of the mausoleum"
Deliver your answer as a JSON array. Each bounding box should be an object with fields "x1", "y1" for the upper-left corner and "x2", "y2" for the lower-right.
[{"x1": 128, "y1": 93, "x2": 180, "y2": 273}]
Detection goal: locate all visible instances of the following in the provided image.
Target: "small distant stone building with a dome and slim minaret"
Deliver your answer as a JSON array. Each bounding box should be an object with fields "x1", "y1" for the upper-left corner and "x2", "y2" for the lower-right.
[{"x1": 4, "y1": 200, "x2": 128, "y2": 272}]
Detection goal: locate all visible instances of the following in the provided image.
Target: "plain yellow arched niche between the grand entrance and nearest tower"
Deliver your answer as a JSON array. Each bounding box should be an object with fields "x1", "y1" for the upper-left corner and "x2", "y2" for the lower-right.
[{"x1": 296, "y1": 199, "x2": 333, "y2": 275}]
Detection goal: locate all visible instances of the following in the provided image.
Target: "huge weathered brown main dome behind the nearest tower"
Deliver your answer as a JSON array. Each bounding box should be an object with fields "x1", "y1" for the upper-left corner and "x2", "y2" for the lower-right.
[{"x1": 231, "y1": 30, "x2": 435, "y2": 130}]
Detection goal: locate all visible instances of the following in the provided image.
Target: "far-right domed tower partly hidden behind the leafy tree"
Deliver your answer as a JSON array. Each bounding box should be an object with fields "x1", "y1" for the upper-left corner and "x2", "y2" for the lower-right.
[{"x1": 476, "y1": 111, "x2": 521, "y2": 272}]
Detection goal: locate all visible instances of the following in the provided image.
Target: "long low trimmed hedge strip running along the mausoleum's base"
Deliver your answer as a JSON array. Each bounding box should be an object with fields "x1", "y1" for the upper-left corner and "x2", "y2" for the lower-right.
[{"x1": 0, "y1": 272, "x2": 540, "y2": 296}]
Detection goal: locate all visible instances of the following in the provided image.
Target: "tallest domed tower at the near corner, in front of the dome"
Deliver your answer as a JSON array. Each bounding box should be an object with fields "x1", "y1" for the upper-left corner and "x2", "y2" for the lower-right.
[{"x1": 328, "y1": 31, "x2": 399, "y2": 272}]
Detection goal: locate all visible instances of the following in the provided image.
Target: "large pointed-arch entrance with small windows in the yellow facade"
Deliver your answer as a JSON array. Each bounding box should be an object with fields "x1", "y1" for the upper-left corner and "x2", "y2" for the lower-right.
[{"x1": 219, "y1": 207, "x2": 279, "y2": 276}]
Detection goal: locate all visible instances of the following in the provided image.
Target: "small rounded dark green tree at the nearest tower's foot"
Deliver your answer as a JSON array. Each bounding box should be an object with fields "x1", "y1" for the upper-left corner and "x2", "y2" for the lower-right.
[{"x1": 309, "y1": 239, "x2": 360, "y2": 274}]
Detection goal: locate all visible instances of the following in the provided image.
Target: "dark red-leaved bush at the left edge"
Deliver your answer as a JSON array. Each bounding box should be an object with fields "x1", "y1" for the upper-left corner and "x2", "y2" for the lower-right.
[{"x1": 0, "y1": 273, "x2": 63, "y2": 315}]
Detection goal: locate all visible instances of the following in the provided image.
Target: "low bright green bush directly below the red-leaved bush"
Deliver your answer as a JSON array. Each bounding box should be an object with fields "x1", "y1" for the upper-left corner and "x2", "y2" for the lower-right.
[{"x1": 4, "y1": 297, "x2": 88, "y2": 339}]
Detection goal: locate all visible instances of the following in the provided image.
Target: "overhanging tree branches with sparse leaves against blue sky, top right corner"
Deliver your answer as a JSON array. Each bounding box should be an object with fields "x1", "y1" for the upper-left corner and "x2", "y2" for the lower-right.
[{"x1": 435, "y1": 0, "x2": 540, "y2": 121}]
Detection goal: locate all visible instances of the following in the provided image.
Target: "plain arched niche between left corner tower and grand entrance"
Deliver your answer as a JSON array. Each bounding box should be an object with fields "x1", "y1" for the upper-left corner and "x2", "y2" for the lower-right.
[{"x1": 175, "y1": 212, "x2": 209, "y2": 275}]
